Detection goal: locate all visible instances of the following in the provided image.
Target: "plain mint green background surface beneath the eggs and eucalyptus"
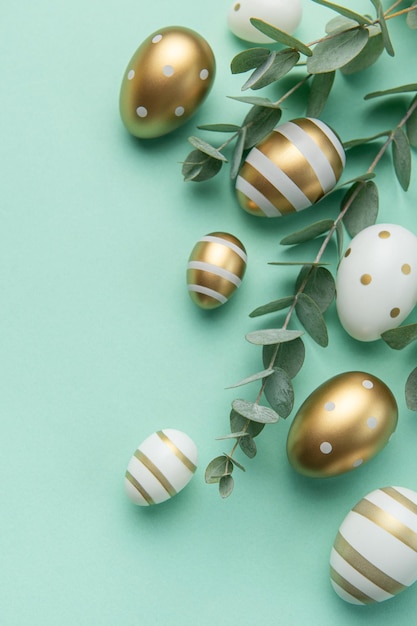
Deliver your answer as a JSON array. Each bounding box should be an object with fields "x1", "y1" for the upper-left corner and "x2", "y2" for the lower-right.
[{"x1": 0, "y1": 0, "x2": 417, "y2": 626}]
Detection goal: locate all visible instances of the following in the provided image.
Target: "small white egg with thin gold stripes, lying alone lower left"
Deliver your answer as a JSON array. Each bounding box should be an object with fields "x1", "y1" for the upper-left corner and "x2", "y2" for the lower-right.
[{"x1": 125, "y1": 428, "x2": 197, "y2": 506}]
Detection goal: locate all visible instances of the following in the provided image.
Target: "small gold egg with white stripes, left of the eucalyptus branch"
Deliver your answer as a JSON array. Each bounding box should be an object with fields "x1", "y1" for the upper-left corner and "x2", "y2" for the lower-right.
[{"x1": 187, "y1": 232, "x2": 247, "y2": 309}]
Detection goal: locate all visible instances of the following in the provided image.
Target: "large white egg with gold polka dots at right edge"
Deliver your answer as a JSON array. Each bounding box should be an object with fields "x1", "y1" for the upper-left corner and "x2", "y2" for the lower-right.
[{"x1": 336, "y1": 224, "x2": 417, "y2": 341}]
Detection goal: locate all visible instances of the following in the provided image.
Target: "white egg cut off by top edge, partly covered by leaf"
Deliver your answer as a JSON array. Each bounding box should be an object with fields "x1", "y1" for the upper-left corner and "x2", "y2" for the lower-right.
[{"x1": 227, "y1": 0, "x2": 303, "y2": 43}]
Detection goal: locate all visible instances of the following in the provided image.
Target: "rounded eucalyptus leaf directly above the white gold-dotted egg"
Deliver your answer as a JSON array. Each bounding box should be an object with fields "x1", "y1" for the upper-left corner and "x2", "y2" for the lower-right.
[{"x1": 341, "y1": 180, "x2": 379, "y2": 237}]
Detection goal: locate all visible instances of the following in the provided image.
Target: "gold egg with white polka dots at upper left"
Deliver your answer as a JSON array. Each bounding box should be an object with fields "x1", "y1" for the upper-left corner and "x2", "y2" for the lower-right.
[{"x1": 120, "y1": 26, "x2": 215, "y2": 138}]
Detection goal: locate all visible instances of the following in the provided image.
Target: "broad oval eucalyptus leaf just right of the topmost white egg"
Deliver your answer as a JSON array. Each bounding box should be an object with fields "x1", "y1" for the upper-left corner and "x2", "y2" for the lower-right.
[{"x1": 307, "y1": 27, "x2": 369, "y2": 74}]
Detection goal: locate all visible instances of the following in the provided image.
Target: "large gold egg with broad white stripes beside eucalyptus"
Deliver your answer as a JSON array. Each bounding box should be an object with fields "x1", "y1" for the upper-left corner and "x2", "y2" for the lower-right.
[{"x1": 236, "y1": 118, "x2": 345, "y2": 217}]
